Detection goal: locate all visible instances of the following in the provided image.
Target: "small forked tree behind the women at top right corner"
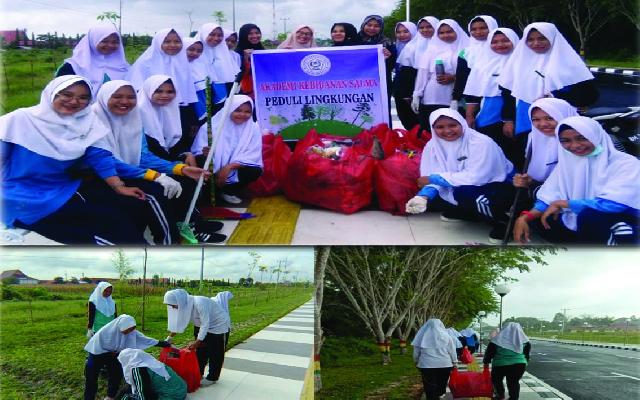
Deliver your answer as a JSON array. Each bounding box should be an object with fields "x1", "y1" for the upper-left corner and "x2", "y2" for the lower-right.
[{"x1": 566, "y1": 0, "x2": 616, "y2": 59}]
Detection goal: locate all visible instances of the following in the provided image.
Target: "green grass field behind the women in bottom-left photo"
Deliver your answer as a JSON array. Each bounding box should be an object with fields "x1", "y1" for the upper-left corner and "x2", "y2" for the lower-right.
[{"x1": 0, "y1": 284, "x2": 312, "y2": 400}]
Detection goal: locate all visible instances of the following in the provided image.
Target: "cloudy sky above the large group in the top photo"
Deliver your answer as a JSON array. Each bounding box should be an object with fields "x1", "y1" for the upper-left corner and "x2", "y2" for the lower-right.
[{"x1": 0, "y1": 0, "x2": 396, "y2": 38}]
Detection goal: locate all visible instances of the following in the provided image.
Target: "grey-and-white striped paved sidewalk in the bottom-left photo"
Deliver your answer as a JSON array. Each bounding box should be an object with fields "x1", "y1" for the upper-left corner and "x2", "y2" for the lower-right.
[{"x1": 187, "y1": 301, "x2": 314, "y2": 400}]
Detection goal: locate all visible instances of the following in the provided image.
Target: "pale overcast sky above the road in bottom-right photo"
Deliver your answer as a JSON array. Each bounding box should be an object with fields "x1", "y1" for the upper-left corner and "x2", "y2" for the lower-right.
[{"x1": 487, "y1": 248, "x2": 640, "y2": 324}]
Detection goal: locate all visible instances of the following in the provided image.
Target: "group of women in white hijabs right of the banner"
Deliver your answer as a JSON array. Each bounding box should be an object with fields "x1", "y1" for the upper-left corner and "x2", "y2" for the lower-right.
[{"x1": 399, "y1": 15, "x2": 640, "y2": 245}]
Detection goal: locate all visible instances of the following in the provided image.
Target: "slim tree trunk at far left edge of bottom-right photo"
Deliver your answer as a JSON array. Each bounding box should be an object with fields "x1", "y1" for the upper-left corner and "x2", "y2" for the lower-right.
[{"x1": 313, "y1": 246, "x2": 331, "y2": 392}]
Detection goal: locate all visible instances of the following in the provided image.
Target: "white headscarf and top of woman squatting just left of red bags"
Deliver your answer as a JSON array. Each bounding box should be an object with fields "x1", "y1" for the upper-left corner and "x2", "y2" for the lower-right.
[{"x1": 191, "y1": 95, "x2": 262, "y2": 183}]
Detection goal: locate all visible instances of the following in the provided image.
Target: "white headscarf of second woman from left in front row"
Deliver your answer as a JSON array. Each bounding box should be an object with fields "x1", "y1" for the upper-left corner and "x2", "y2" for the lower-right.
[{"x1": 91, "y1": 80, "x2": 142, "y2": 165}]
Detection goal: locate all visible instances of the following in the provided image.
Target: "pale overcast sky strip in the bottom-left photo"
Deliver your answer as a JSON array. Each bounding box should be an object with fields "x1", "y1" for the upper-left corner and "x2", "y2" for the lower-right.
[{"x1": 0, "y1": 246, "x2": 313, "y2": 282}]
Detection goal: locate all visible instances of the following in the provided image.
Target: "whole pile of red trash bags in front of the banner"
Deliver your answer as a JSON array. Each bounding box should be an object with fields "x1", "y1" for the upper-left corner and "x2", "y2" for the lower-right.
[{"x1": 247, "y1": 124, "x2": 431, "y2": 215}]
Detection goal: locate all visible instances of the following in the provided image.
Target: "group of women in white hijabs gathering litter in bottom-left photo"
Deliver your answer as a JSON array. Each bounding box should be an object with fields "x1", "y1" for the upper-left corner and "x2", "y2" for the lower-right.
[{"x1": 84, "y1": 282, "x2": 233, "y2": 400}]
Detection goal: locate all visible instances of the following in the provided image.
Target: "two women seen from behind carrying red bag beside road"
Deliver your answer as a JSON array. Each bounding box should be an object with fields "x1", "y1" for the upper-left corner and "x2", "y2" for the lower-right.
[{"x1": 411, "y1": 318, "x2": 531, "y2": 400}]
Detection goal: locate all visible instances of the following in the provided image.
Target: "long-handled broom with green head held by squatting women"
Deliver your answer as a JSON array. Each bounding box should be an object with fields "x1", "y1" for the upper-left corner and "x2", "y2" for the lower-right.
[{"x1": 178, "y1": 74, "x2": 240, "y2": 244}]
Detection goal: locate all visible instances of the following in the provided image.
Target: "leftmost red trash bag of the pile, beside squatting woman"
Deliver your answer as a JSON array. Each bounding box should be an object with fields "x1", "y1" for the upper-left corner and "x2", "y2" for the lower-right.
[{"x1": 246, "y1": 133, "x2": 292, "y2": 197}]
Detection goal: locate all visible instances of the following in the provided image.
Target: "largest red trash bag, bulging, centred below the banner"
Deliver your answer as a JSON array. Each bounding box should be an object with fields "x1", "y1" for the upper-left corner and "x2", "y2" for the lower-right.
[{"x1": 282, "y1": 129, "x2": 375, "y2": 214}]
